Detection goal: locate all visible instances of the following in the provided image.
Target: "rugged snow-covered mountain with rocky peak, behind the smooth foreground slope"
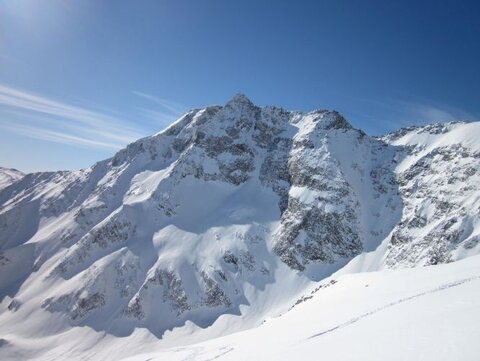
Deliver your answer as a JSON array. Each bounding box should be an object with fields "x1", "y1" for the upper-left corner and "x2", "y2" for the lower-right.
[{"x1": 0, "y1": 95, "x2": 480, "y2": 359}]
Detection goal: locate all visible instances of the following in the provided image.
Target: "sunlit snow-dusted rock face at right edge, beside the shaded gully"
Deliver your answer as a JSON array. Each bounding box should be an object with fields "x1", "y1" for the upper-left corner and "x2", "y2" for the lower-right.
[{"x1": 378, "y1": 123, "x2": 480, "y2": 267}]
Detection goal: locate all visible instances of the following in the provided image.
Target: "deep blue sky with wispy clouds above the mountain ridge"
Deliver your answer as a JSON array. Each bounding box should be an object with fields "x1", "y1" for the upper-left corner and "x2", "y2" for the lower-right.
[{"x1": 0, "y1": 0, "x2": 480, "y2": 171}]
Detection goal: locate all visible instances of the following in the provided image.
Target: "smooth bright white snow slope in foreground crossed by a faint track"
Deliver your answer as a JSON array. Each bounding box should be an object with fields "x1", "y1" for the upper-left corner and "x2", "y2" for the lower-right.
[{"x1": 121, "y1": 256, "x2": 480, "y2": 361}]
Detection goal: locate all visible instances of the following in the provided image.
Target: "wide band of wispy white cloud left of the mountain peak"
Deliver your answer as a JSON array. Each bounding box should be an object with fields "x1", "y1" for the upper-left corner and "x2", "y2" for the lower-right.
[{"x1": 0, "y1": 84, "x2": 145, "y2": 149}]
